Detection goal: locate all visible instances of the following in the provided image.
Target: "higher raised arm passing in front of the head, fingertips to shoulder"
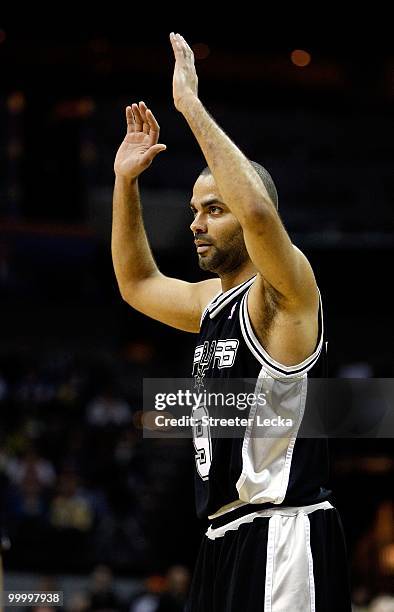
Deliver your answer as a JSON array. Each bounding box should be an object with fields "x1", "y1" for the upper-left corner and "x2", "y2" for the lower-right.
[{"x1": 170, "y1": 34, "x2": 317, "y2": 307}]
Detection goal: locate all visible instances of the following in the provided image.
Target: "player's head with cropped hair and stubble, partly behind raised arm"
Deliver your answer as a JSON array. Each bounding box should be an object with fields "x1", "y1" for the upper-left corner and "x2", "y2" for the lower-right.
[{"x1": 190, "y1": 161, "x2": 278, "y2": 275}]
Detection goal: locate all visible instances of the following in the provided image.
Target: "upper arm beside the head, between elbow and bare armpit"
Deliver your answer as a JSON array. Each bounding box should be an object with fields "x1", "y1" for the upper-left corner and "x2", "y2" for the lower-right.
[{"x1": 244, "y1": 211, "x2": 316, "y2": 302}]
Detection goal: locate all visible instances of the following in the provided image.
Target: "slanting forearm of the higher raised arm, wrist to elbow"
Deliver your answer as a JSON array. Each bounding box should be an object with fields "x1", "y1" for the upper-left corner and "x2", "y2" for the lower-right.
[{"x1": 181, "y1": 96, "x2": 272, "y2": 224}]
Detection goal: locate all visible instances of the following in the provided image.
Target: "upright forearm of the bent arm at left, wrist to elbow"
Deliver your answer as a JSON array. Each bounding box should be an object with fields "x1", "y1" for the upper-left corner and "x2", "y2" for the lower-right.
[{"x1": 111, "y1": 176, "x2": 157, "y2": 293}]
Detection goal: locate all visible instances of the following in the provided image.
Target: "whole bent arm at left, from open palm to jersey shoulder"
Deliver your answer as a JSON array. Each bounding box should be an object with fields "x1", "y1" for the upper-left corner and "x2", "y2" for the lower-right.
[{"x1": 112, "y1": 102, "x2": 220, "y2": 333}]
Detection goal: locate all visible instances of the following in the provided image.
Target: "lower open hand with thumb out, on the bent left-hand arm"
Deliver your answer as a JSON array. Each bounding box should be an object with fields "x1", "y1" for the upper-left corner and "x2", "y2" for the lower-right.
[{"x1": 114, "y1": 102, "x2": 167, "y2": 180}]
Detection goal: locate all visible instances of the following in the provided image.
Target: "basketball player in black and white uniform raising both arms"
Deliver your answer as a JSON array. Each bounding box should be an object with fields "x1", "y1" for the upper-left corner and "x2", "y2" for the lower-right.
[{"x1": 112, "y1": 33, "x2": 351, "y2": 612}]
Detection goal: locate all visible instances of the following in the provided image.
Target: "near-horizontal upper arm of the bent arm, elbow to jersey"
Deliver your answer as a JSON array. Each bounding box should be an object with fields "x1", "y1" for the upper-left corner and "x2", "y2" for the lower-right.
[{"x1": 122, "y1": 272, "x2": 220, "y2": 333}]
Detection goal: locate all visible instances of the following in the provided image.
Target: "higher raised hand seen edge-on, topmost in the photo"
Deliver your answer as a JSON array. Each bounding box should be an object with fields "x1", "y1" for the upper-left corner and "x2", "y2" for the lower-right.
[{"x1": 170, "y1": 32, "x2": 198, "y2": 112}]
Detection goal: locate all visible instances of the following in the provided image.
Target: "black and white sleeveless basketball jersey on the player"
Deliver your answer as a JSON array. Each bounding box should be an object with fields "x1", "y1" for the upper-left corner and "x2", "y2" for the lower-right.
[{"x1": 193, "y1": 276, "x2": 330, "y2": 517}]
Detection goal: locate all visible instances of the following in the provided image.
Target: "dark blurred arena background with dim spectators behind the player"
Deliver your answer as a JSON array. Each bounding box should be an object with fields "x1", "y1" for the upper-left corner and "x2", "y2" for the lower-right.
[{"x1": 0, "y1": 19, "x2": 394, "y2": 612}]
